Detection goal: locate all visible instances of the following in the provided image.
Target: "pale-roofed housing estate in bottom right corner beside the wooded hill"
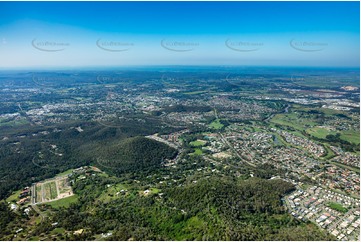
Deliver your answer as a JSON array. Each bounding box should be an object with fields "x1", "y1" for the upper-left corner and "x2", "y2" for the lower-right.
[{"x1": 285, "y1": 186, "x2": 360, "y2": 240}]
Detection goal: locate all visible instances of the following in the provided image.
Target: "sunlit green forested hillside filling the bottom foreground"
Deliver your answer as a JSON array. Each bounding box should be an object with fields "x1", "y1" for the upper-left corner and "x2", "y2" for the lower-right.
[{"x1": 28, "y1": 176, "x2": 335, "y2": 241}]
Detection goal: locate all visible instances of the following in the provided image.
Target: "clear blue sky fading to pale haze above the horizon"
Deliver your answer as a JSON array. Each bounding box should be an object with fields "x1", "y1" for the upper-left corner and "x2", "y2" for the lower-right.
[{"x1": 0, "y1": 2, "x2": 360, "y2": 68}]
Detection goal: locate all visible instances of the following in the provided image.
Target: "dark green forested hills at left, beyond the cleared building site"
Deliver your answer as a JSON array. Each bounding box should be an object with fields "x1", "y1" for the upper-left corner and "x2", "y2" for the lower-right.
[{"x1": 0, "y1": 121, "x2": 177, "y2": 199}]
